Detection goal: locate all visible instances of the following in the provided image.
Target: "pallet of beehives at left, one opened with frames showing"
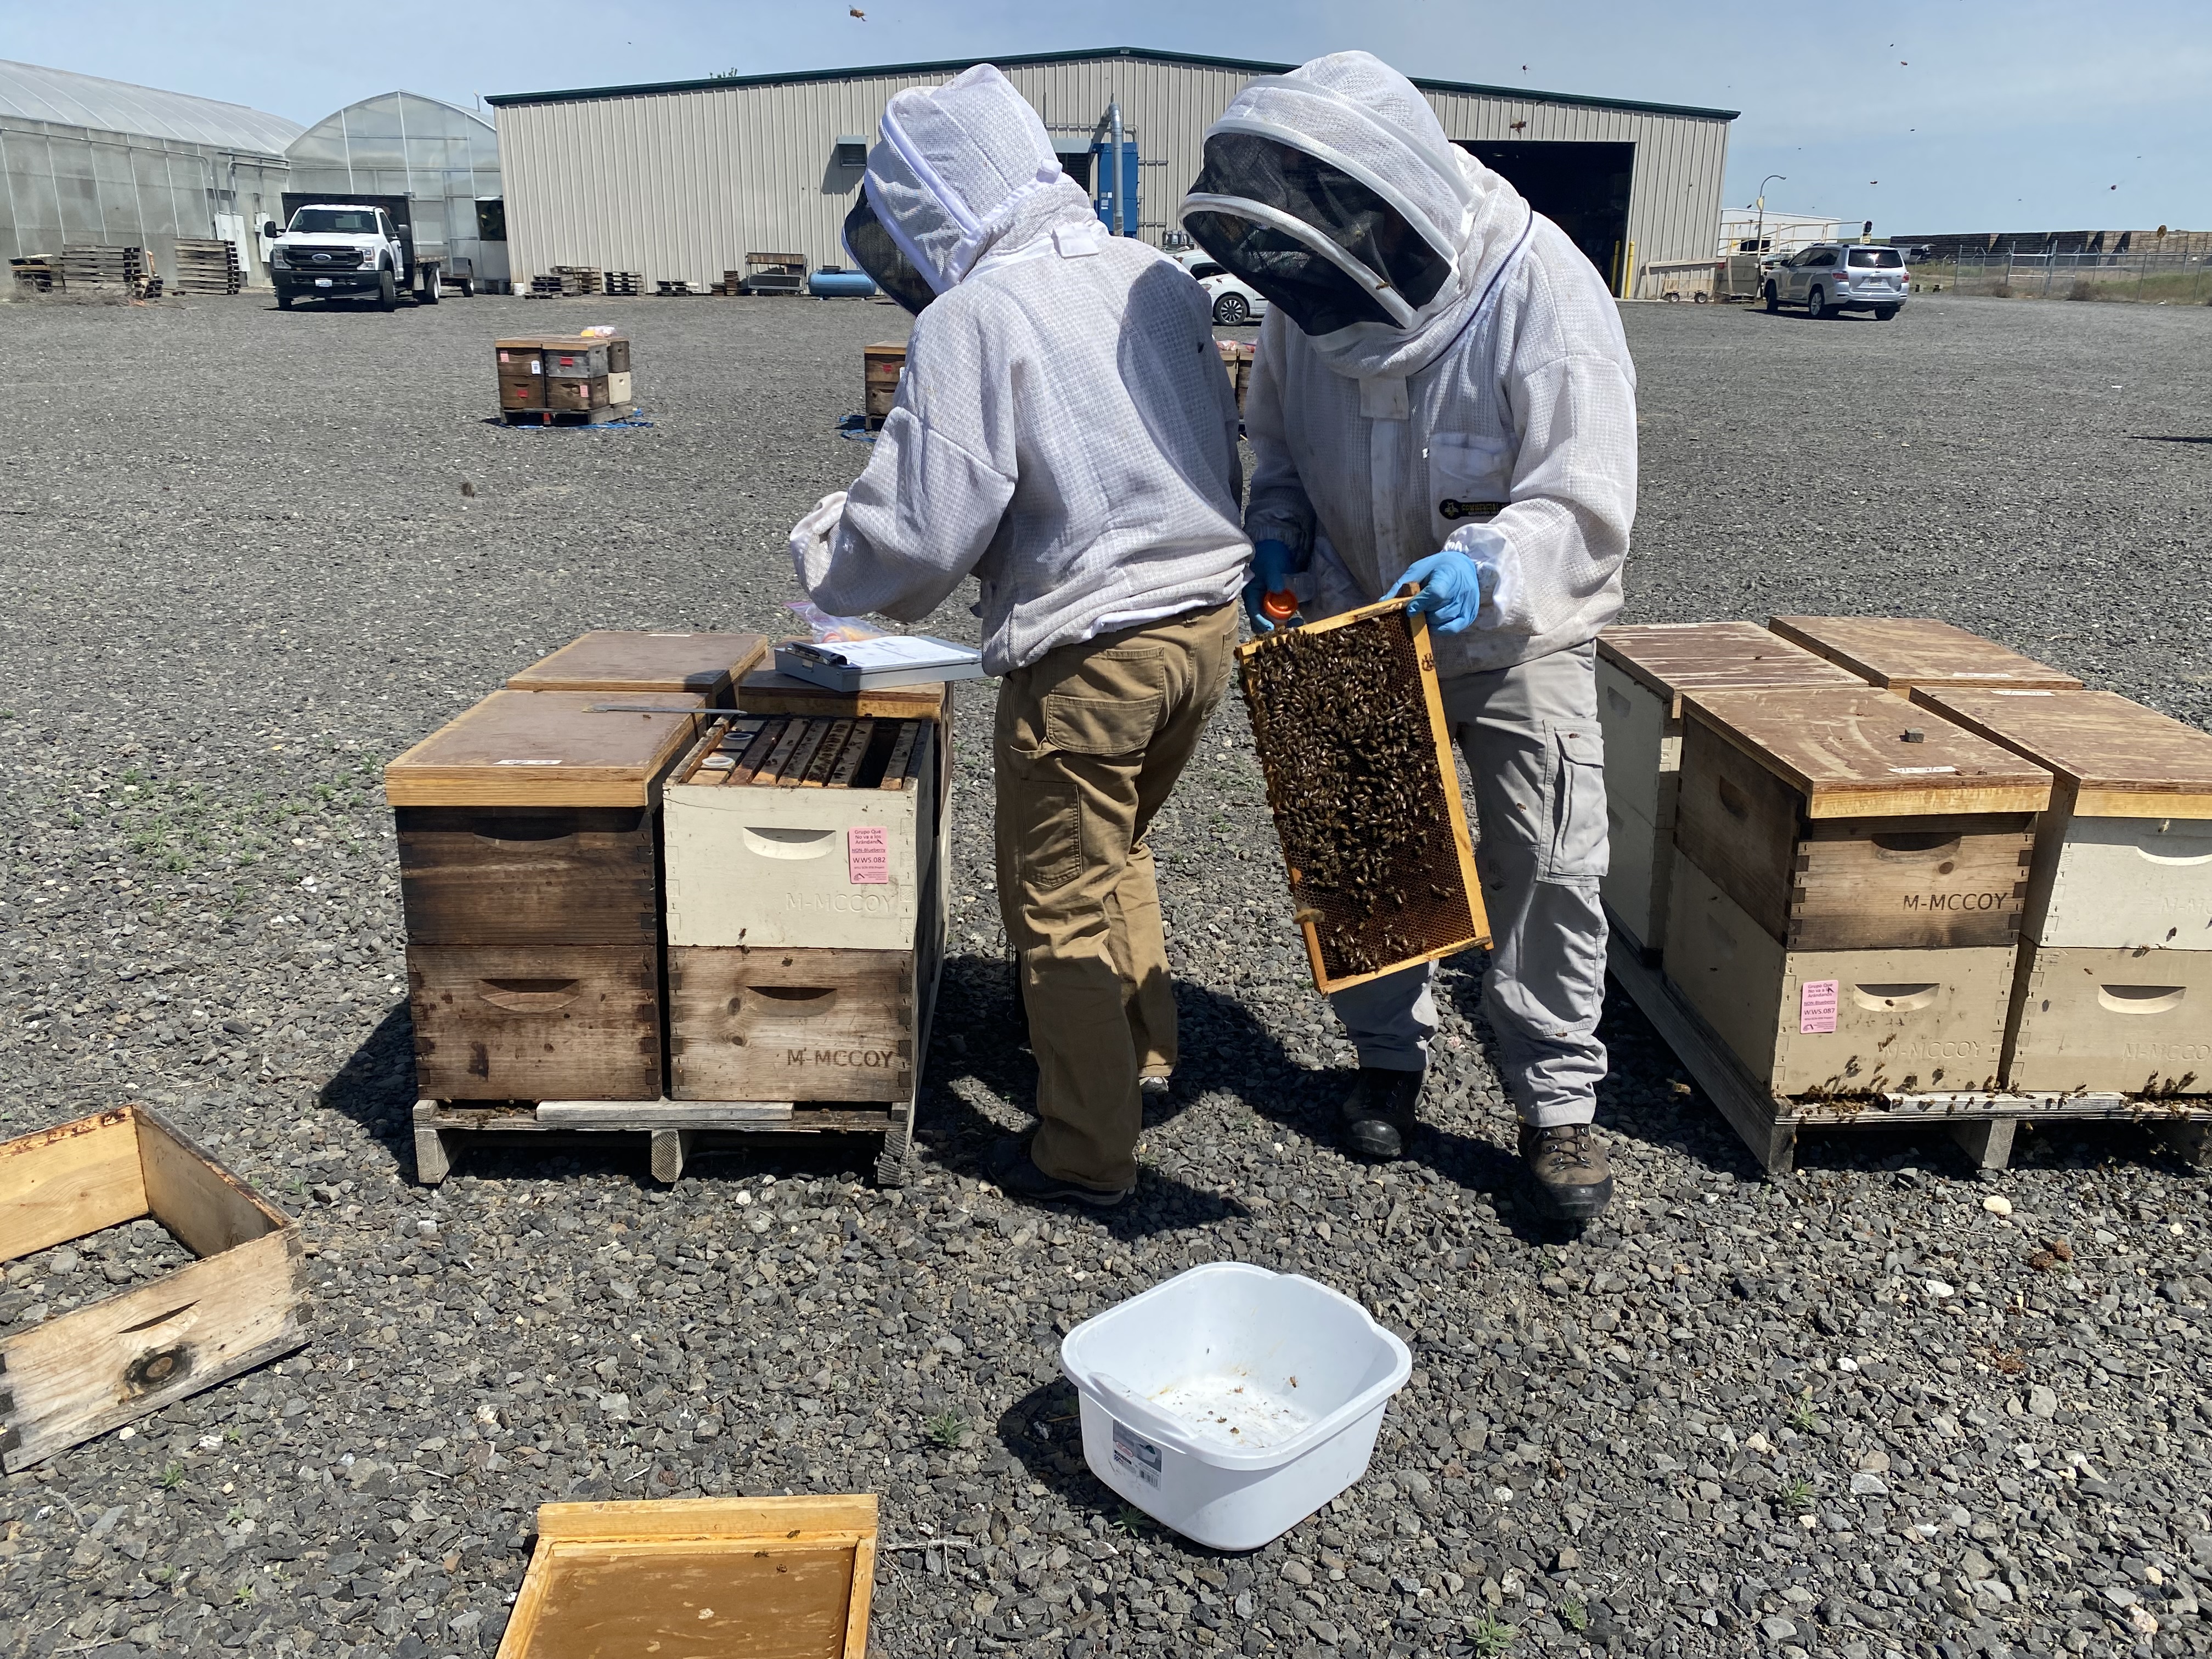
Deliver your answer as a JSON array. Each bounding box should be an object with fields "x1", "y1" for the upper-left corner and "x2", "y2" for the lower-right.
[{"x1": 385, "y1": 633, "x2": 949, "y2": 1181}]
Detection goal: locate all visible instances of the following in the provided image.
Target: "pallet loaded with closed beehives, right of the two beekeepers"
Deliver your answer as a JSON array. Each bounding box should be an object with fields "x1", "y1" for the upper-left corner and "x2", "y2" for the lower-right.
[{"x1": 1599, "y1": 617, "x2": 2212, "y2": 1170}]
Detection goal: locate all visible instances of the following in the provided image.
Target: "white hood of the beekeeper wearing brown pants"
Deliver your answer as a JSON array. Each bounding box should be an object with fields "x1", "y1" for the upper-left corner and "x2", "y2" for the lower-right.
[{"x1": 865, "y1": 64, "x2": 1093, "y2": 294}]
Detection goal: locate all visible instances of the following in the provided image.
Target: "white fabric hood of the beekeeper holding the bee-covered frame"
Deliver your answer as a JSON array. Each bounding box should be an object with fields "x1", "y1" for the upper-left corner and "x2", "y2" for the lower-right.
[{"x1": 1186, "y1": 51, "x2": 1528, "y2": 378}]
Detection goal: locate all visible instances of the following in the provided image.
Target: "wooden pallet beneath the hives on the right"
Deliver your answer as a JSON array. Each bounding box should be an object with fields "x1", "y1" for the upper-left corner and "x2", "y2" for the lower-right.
[{"x1": 1606, "y1": 911, "x2": 2212, "y2": 1177}]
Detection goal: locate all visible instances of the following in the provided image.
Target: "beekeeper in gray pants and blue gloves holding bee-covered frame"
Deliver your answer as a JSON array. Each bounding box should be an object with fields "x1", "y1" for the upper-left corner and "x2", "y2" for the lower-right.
[{"x1": 1183, "y1": 51, "x2": 1637, "y2": 1217}]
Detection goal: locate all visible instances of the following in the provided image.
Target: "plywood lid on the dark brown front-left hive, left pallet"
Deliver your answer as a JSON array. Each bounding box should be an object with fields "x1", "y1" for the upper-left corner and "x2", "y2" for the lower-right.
[{"x1": 385, "y1": 690, "x2": 706, "y2": 808}]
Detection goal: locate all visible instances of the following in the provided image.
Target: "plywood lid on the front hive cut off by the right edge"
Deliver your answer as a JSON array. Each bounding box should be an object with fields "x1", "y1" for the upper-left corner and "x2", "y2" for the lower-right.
[{"x1": 1914, "y1": 688, "x2": 2212, "y2": 819}]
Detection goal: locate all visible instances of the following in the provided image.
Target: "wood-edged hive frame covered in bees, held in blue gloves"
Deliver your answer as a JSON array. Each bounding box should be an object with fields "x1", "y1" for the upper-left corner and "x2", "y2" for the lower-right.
[{"x1": 1237, "y1": 600, "x2": 1491, "y2": 993}]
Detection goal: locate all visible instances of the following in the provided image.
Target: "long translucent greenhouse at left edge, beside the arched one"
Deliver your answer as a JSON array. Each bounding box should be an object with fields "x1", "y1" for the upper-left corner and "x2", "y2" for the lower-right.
[{"x1": 0, "y1": 62, "x2": 301, "y2": 276}]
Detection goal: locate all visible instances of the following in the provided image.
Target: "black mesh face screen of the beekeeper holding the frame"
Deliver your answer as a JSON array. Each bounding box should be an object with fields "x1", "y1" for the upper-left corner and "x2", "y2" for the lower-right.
[{"x1": 1183, "y1": 133, "x2": 1451, "y2": 334}]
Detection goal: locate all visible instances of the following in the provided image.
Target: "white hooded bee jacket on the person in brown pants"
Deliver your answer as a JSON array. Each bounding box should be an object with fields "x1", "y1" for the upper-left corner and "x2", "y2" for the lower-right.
[{"x1": 792, "y1": 64, "x2": 1250, "y2": 675}]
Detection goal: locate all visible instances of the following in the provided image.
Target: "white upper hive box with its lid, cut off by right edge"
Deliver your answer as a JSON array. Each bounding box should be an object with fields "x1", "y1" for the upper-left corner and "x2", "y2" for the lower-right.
[{"x1": 1914, "y1": 688, "x2": 2212, "y2": 946}]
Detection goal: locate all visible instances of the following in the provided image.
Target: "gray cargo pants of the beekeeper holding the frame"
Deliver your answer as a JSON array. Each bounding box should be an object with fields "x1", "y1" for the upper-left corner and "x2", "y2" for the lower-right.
[{"x1": 1329, "y1": 644, "x2": 1606, "y2": 1128}]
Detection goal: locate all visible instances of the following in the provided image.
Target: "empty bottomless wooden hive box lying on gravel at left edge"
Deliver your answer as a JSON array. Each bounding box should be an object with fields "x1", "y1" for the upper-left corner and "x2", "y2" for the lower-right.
[{"x1": 0, "y1": 1106, "x2": 307, "y2": 1473}]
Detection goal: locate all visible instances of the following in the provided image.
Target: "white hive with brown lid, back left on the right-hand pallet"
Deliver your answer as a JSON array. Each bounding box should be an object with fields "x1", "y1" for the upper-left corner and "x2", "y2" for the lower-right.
[{"x1": 1597, "y1": 622, "x2": 1863, "y2": 951}]
